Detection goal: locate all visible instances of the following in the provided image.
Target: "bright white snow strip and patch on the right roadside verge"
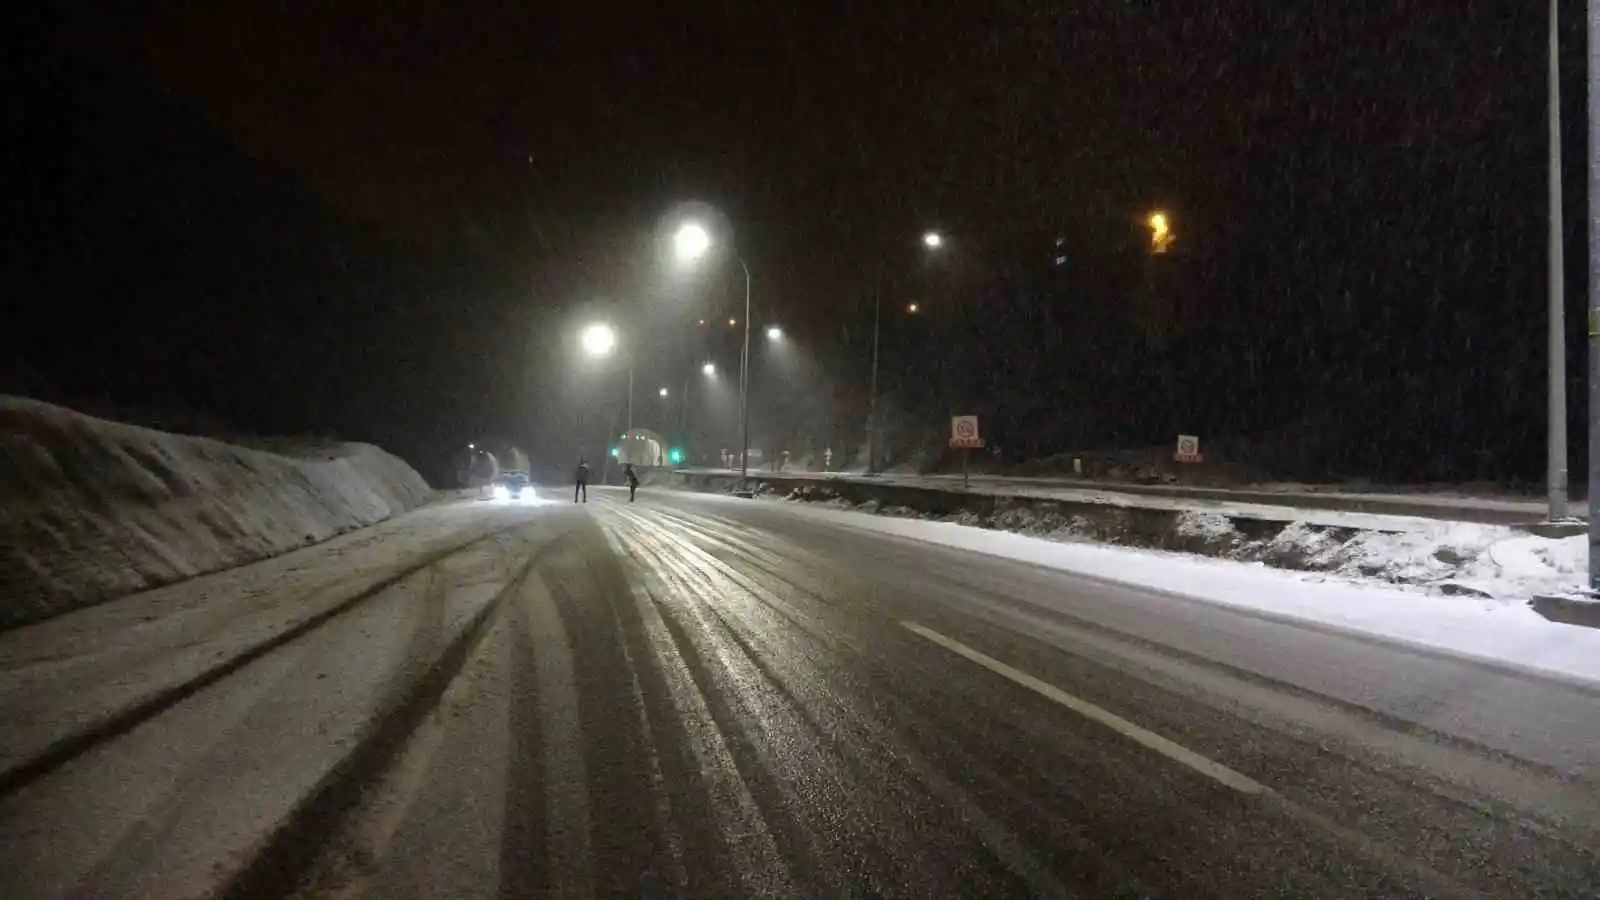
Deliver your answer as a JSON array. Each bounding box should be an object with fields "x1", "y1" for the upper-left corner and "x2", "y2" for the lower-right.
[{"x1": 755, "y1": 503, "x2": 1600, "y2": 682}]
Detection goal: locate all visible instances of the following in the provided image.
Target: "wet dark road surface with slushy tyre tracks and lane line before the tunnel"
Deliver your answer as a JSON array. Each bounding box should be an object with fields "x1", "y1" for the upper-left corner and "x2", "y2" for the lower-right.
[{"x1": 0, "y1": 488, "x2": 1600, "y2": 898}]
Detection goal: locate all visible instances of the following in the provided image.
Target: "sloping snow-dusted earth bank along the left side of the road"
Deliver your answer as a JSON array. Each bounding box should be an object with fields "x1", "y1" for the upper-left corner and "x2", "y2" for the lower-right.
[{"x1": 0, "y1": 396, "x2": 432, "y2": 628}]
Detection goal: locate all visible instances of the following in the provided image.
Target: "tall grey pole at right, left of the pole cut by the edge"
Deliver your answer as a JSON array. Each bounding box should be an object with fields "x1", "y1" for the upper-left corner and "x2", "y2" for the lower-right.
[{"x1": 1546, "y1": 0, "x2": 1566, "y2": 520}]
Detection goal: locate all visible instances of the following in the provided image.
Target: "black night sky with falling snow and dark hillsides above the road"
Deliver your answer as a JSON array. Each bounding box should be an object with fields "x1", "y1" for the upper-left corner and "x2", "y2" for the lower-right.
[{"x1": 0, "y1": 0, "x2": 1586, "y2": 480}]
